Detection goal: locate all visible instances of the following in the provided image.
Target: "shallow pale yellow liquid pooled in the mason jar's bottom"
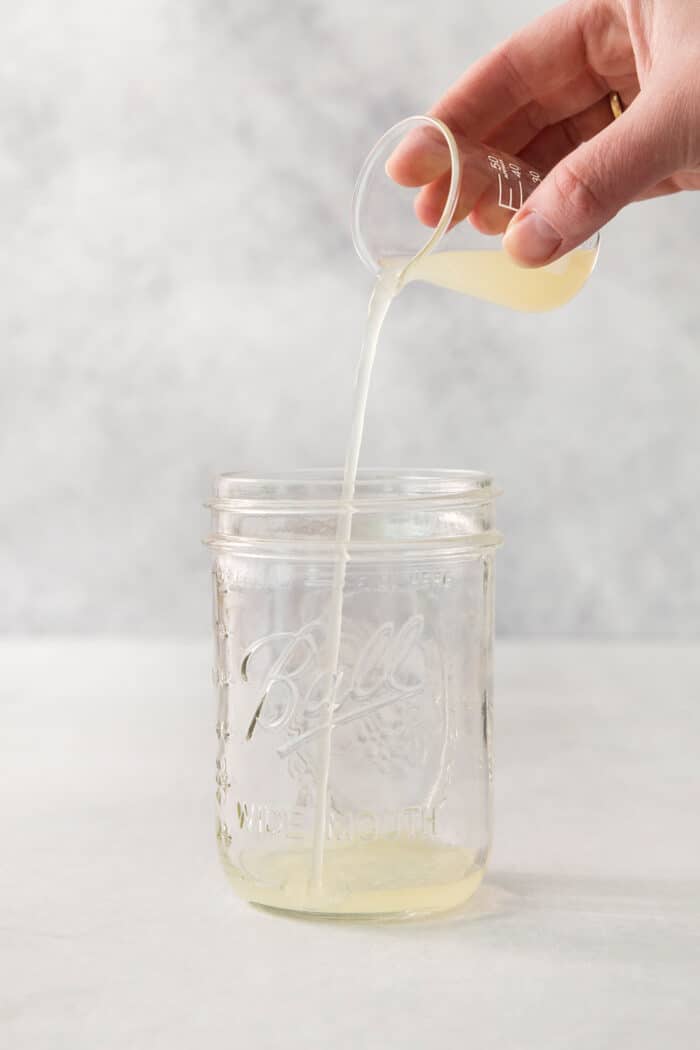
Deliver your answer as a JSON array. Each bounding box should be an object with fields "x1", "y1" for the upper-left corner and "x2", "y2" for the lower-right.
[{"x1": 219, "y1": 839, "x2": 486, "y2": 916}]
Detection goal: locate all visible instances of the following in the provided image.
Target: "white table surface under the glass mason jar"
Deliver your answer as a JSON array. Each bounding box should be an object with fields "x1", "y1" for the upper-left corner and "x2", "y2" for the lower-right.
[{"x1": 0, "y1": 639, "x2": 700, "y2": 1050}]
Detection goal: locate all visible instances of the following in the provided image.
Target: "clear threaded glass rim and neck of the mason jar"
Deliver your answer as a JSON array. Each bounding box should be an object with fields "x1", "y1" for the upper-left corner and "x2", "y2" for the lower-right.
[{"x1": 206, "y1": 467, "x2": 502, "y2": 562}]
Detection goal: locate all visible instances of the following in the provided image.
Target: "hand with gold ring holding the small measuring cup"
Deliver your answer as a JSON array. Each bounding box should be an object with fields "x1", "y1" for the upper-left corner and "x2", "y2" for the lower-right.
[{"x1": 388, "y1": 0, "x2": 700, "y2": 266}]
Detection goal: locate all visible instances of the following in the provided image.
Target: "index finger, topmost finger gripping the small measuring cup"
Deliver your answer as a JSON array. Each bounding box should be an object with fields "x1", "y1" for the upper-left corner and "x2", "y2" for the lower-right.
[{"x1": 386, "y1": 0, "x2": 600, "y2": 186}]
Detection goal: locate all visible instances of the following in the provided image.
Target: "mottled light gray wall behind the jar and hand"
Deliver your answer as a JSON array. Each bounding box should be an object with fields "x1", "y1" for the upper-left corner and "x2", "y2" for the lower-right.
[{"x1": 0, "y1": 0, "x2": 700, "y2": 636}]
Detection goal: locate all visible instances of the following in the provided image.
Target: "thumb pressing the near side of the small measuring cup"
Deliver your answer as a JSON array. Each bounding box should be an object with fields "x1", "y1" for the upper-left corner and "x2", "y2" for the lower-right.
[{"x1": 503, "y1": 96, "x2": 677, "y2": 267}]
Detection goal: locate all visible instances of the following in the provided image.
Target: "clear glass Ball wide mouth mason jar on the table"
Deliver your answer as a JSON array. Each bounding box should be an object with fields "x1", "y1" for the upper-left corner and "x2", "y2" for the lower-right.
[{"x1": 208, "y1": 470, "x2": 501, "y2": 915}]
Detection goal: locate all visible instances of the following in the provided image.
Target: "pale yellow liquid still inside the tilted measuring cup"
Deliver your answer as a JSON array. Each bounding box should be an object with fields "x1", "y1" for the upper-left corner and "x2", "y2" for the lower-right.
[{"x1": 398, "y1": 248, "x2": 597, "y2": 312}]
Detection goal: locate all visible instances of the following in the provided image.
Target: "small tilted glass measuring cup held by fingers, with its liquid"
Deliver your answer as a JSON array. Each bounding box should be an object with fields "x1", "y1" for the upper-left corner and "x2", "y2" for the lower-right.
[{"x1": 353, "y1": 117, "x2": 600, "y2": 311}]
